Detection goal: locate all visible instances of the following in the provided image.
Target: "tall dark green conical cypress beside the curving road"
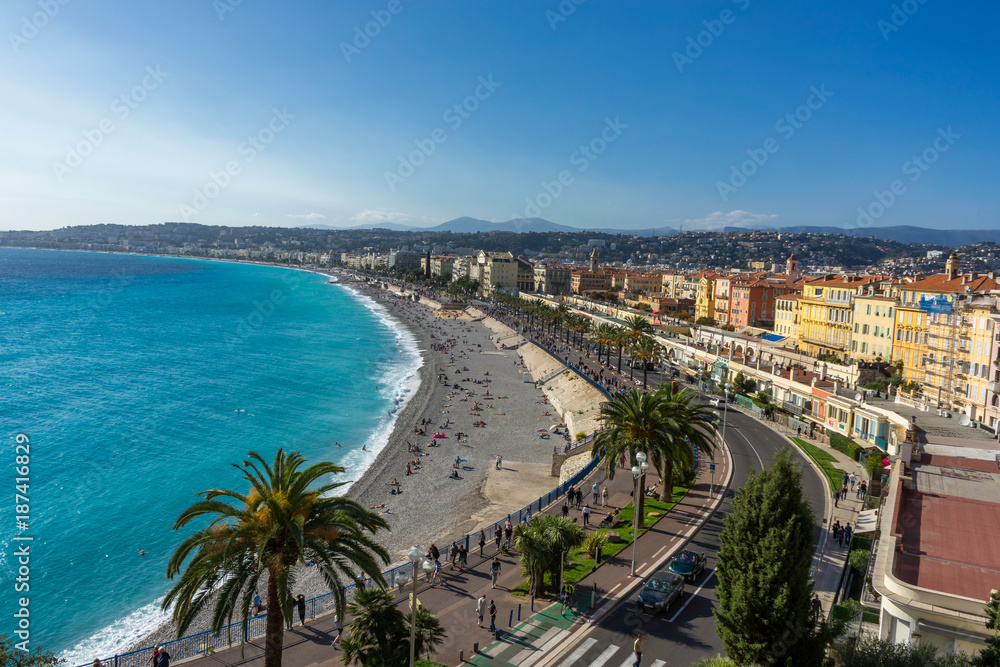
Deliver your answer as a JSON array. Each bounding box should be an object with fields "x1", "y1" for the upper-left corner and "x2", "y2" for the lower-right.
[{"x1": 715, "y1": 450, "x2": 840, "y2": 667}]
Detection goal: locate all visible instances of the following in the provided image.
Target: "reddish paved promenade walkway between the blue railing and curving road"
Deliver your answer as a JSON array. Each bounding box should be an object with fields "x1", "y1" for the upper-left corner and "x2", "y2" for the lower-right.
[{"x1": 176, "y1": 434, "x2": 732, "y2": 667}]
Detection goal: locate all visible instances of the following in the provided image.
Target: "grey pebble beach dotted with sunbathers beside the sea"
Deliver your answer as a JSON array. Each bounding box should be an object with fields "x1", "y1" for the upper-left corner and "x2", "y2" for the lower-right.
[{"x1": 132, "y1": 274, "x2": 584, "y2": 649}]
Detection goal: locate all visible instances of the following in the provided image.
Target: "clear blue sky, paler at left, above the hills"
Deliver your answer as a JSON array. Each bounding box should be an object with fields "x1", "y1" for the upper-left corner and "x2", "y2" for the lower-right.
[{"x1": 0, "y1": 0, "x2": 1000, "y2": 229}]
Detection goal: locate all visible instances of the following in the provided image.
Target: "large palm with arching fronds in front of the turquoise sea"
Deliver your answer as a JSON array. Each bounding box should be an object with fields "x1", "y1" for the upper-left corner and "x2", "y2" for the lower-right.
[{"x1": 163, "y1": 449, "x2": 389, "y2": 667}]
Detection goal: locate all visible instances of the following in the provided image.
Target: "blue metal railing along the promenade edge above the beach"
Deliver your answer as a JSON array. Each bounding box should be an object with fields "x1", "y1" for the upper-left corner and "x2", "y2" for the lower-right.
[{"x1": 78, "y1": 318, "x2": 611, "y2": 667}]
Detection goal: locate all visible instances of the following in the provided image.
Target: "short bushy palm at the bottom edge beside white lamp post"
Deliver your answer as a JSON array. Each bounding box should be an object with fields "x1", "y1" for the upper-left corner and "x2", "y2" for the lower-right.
[{"x1": 341, "y1": 588, "x2": 445, "y2": 667}]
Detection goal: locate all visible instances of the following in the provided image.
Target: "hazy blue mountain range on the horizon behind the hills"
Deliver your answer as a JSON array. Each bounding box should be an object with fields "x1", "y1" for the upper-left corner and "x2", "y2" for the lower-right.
[{"x1": 302, "y1": 217, "x2": 1000, "y2": 246}]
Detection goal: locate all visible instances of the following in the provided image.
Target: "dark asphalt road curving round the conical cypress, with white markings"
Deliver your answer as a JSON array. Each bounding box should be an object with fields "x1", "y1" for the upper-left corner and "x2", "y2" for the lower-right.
[{"x1": 546, "y1": 410, "x2": 827, "y2": 667}]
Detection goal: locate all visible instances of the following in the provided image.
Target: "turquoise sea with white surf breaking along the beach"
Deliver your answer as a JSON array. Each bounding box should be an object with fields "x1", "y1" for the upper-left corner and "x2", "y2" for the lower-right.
[{"x1": 0, "y1": 248, "x2": 421, "y2": 664}]
